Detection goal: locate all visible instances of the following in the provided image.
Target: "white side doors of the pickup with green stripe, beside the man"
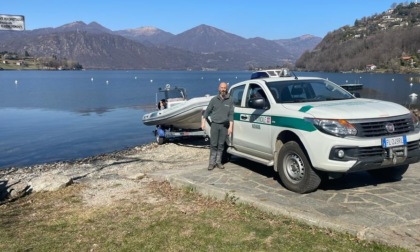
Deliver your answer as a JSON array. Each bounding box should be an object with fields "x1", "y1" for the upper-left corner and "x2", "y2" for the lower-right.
[{"x1": 230, "y1": 83, "x2": 272, "y2": 159}]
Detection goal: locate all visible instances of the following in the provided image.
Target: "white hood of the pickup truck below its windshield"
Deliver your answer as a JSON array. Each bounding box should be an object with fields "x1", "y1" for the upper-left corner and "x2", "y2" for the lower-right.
[{"x1": 283, "y1": 98, "x2": 409, "y2": 119}]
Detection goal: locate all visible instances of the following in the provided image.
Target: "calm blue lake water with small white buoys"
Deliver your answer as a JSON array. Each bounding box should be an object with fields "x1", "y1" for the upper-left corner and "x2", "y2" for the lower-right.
[{"x1": 0, "y1": 71, "x2": 420, "y2": 168}]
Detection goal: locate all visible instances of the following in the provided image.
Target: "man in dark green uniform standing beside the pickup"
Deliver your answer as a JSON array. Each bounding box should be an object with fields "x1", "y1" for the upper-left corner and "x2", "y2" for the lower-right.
[{"x1": 201, "y1": 82, "x2": 233, "y2": 170}]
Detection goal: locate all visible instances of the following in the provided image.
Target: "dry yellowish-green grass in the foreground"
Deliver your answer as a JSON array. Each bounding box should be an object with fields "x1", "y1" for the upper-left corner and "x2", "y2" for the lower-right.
[{"x1": 0, "y1": 181, "x2": 404, "y2": 251}]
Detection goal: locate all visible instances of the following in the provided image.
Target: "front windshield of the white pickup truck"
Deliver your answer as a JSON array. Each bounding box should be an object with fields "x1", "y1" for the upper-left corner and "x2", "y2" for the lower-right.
[{"x1": 267, "y1": 79, "x2": 354, "y2": 103}]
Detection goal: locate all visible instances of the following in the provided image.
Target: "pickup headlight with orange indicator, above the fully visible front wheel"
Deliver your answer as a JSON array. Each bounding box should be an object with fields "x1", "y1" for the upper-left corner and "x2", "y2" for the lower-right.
[{"x1": 307, "y1": 118, "x2": 357, "y2": 137}]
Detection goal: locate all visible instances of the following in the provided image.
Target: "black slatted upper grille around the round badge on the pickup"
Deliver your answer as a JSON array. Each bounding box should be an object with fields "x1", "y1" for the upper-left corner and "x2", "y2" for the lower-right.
[{"x1": 351, "y1": 115, "x2": 414, "y2": 137}]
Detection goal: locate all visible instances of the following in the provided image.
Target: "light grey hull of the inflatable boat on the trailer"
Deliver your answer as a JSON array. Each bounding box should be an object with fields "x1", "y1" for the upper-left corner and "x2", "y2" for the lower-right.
[{"x1": 143, "y1": 96, "x2": 212, "y2": 129}]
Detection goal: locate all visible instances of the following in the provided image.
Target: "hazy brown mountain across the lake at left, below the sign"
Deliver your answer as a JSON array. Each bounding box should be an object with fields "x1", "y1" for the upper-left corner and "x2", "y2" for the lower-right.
[{"x1": 0, "y1": 31, "x2": 199, "y2": 69}]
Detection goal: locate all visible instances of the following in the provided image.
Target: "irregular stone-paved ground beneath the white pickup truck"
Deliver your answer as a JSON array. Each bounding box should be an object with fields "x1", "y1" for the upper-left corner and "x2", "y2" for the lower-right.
[{"x1": 151, "y1": 158, "x2": 420, "y2": 251}]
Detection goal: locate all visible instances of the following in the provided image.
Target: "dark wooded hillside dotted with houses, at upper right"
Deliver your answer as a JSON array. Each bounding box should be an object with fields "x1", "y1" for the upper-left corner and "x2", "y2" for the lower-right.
[{"x1": 296, "y1": 3, "x2": 420, "y2": 72}]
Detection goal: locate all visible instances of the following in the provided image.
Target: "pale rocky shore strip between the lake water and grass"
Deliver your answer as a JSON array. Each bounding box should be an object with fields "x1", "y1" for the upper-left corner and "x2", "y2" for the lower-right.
[{"x1": 0, "y1": 139, "x2": 209, "y2": 204}]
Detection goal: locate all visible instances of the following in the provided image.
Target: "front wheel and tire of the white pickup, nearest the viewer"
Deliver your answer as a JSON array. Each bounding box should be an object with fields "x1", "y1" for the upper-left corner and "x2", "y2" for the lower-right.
[{"x1": 277, "y1": 141, "x2": 322, "y2": 193}]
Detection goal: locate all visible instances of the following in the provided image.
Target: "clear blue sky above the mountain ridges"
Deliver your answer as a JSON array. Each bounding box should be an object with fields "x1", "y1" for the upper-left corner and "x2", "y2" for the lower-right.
[{"x1": 0, "y1": 0, "x2": 415, "y2": 40}]
